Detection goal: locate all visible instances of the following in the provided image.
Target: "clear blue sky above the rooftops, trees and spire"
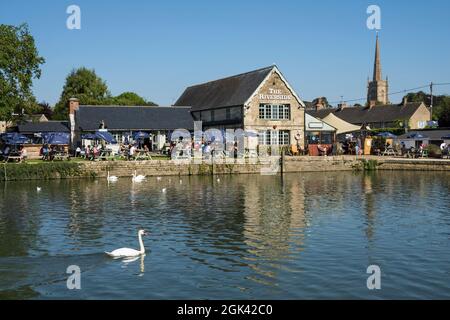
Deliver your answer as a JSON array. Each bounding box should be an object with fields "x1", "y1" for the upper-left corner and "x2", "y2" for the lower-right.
[{"x1": 0, "y1": 0, "x2": 450, "y2": 105}]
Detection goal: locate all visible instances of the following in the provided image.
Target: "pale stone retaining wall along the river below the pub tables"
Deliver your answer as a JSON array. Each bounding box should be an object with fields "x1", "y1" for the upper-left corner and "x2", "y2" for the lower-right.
[{"x1": 78, "y1": 156, "x2": 450, "y2": 177}]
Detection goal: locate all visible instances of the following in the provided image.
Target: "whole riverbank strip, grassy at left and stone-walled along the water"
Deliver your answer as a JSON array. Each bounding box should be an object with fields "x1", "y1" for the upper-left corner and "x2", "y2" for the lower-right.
[{"x1": 0, "y1": 156, "x2": 450, "y2": 181}]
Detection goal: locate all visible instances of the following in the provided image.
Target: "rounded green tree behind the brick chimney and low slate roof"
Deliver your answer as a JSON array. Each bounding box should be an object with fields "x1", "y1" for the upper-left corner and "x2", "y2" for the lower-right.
[{"x1": 54, "y1": 67, "x2": 111, "y2": 120}]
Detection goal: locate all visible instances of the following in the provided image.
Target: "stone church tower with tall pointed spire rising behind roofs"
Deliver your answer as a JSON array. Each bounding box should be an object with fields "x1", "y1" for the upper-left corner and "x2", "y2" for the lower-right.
[{"x1": 367, "y1": 34, "x2": 389, "y2": 106}]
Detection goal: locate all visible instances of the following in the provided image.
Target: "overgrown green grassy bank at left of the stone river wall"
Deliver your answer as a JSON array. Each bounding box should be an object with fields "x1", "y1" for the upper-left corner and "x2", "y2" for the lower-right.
[{"x1": 0, "y1": 161, "x2": 85, "y2": 181}]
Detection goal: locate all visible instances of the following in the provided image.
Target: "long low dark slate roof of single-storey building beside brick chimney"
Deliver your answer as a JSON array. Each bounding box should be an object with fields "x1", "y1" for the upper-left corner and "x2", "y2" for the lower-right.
[{"x1": 76, "y1": 106, "x2": 194, "y2": 131}]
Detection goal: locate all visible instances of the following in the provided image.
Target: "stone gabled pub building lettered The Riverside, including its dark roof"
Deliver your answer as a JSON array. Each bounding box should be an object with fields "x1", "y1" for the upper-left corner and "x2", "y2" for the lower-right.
[{"x1": 175, "y1": 66, "x2": 305, "y2": 149}]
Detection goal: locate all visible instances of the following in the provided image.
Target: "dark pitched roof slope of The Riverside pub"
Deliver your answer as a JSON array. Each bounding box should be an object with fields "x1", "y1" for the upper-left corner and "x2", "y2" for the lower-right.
[{"x1": 175, "y1": 66, "x2": 275, "y2": 111}]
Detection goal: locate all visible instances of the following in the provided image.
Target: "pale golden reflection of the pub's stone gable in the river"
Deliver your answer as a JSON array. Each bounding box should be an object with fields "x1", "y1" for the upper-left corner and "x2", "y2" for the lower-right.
[{"x1": 243, "y1": 175, "x2": 307, "y2": 283}]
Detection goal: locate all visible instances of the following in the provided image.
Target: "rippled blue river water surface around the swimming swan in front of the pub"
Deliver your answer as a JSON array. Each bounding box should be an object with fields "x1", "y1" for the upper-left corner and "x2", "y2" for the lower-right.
[{"x1": 0, "y1": 172, "x2": 450, "y2": 299}]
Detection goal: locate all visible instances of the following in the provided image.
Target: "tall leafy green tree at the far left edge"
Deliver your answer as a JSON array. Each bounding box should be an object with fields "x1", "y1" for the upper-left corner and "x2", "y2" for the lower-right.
[{"x1": 0, "y1": 24, "x2": 45, "y2": 121}]
